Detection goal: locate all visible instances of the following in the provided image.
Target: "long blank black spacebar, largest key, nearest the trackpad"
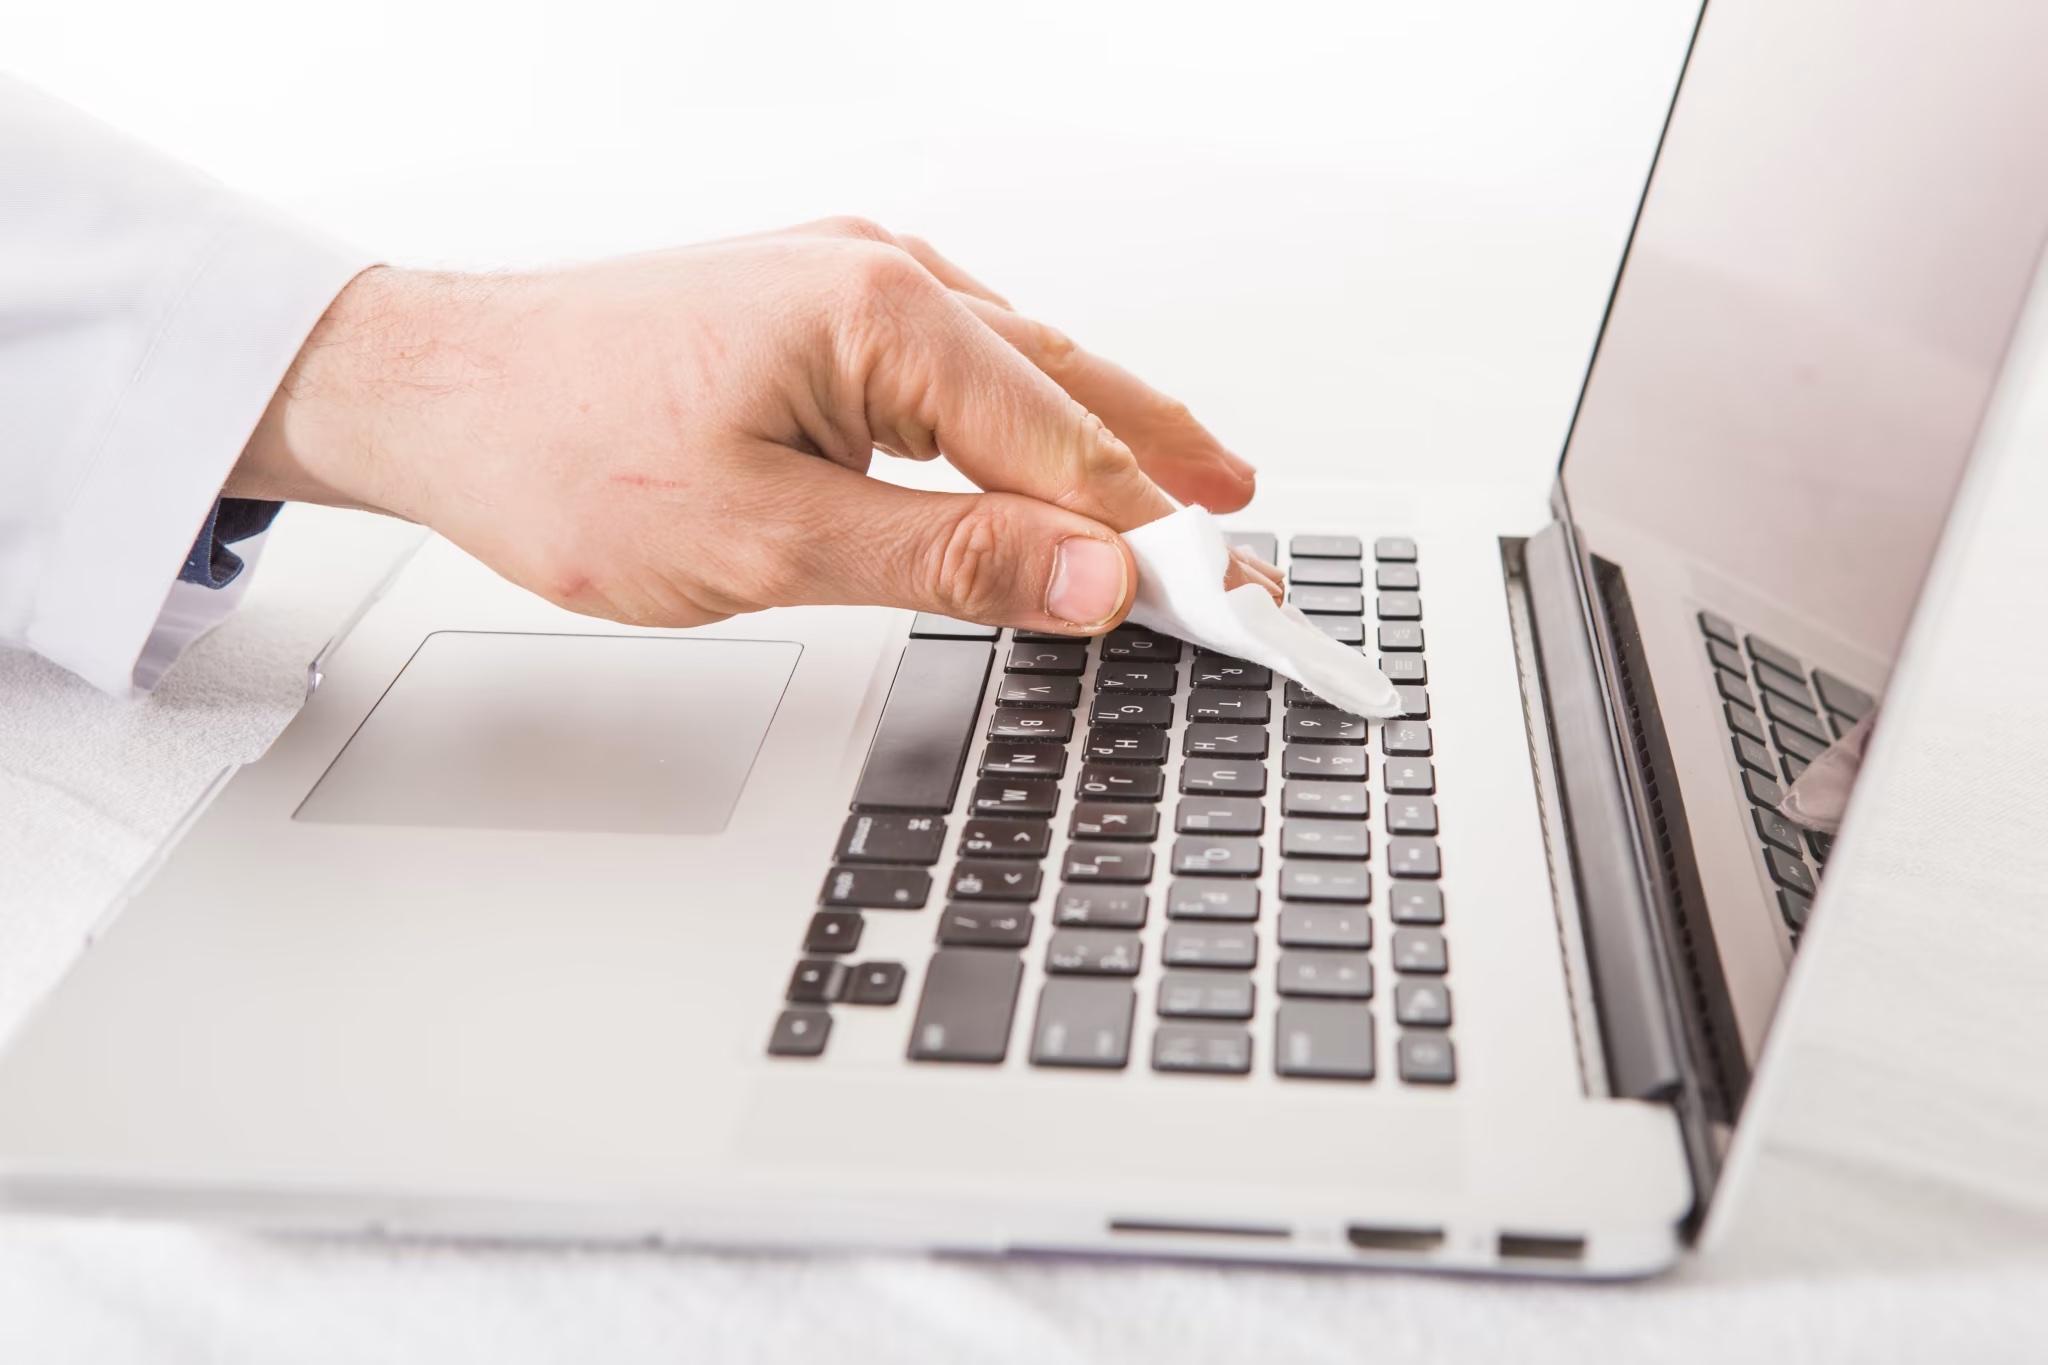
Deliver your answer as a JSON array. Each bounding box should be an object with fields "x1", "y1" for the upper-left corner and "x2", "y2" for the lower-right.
[{"x1": 854, "y1": 641, "x2": 995, "y2": 812}]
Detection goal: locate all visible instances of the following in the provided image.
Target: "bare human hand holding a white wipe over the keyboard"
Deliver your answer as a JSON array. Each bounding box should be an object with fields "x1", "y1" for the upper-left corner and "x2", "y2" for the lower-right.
[{"x1": 227, "y1": 219, "x2": 1280, "y2": 634}]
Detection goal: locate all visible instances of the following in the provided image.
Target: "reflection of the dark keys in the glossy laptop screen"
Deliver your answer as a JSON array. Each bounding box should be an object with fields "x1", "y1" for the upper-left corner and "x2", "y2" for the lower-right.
[{"x1": 1700, "y1": 612, "x2": 1876, "y2": 943}]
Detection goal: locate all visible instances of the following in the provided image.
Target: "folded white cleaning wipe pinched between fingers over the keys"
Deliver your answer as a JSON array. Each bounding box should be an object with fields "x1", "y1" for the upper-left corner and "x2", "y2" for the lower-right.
[{"x1": 1124, "y1": 508, "x2": 1401, "y2": 720}]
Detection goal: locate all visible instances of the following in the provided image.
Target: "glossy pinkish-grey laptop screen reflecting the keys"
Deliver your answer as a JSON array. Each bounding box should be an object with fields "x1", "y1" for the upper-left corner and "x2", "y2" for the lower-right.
[{"x1": 1561, "y1": 0, "x2": 2048, "y2": 1058}]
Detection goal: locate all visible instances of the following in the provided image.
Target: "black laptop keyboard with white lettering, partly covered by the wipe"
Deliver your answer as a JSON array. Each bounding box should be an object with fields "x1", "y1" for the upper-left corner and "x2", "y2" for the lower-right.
[{"x1": 768, "y1": 532, "x2": 1456, "y2": 1087}]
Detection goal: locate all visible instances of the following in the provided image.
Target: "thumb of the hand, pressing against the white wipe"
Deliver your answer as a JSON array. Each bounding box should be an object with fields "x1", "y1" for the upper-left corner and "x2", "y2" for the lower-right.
[{"x1": 778, "y1": 460, "x2": 1139, "y2": 634}]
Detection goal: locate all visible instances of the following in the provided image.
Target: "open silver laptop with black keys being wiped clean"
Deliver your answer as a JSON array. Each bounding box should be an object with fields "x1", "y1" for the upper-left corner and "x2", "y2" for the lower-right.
[{"x1": 0, "y1": 0, "x2": 2048, "y2": 1277}]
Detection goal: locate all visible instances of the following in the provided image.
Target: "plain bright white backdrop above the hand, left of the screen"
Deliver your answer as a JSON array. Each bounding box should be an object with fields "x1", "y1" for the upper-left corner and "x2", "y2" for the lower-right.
[{"x1": 0, "y1": 0, "x2": 1696, "y2": 491}]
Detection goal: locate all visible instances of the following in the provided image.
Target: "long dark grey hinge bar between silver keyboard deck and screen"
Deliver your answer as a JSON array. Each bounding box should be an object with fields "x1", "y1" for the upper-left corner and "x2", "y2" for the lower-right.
[{"x1": 1524, "y1": 522, "x2": 1681, "y2": 1099}]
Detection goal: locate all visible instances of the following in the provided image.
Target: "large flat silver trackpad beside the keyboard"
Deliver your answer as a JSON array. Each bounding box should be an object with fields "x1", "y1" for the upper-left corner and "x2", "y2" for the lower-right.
[{"x1": 293, "y1": 630, "x2": 803, "y2": 835}]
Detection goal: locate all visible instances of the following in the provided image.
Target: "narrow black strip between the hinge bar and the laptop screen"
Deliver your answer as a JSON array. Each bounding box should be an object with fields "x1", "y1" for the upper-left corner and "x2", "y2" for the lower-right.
[{"x1": 1593, "y1": 557, "x2": 1747, "y2": 1119}]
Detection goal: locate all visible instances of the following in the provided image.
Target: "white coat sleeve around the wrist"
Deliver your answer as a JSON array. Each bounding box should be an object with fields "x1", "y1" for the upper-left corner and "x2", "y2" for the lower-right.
[{"x1": 0, "y1": 76, "x2": 373, "y2": 694}]
